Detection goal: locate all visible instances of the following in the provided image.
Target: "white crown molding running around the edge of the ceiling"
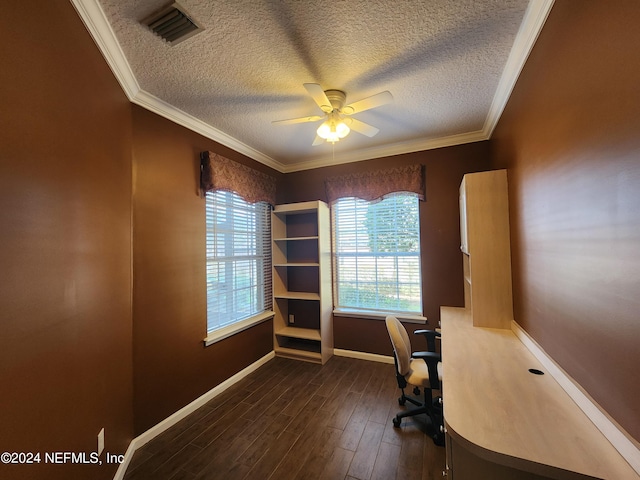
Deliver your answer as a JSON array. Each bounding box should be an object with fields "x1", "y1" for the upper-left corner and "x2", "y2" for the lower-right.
[{"x1": 71, "y1": 0, "x2": 554, "y2": 173}]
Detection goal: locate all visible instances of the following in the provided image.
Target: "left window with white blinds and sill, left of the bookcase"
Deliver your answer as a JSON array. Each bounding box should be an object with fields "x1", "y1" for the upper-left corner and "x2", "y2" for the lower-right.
[{"x1": 204, "y1": 190, "x2": 275, "y2": 346}]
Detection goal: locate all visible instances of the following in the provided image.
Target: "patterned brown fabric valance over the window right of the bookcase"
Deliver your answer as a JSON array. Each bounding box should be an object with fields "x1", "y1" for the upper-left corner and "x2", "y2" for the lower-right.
[{"x1": 325, "y1": 164, "x2": 425, "y2": 203}]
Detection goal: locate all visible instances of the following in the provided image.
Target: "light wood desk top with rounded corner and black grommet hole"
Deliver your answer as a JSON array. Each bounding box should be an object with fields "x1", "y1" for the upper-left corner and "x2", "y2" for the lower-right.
[{"x1": 441, "y1": 307, "x2": 640, "y2": 480}]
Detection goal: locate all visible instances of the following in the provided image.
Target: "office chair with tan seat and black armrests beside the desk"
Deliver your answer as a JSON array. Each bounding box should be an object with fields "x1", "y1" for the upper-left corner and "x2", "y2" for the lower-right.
[{"x1": 385, "y1": 316, "x2": 444, "y2": 445}]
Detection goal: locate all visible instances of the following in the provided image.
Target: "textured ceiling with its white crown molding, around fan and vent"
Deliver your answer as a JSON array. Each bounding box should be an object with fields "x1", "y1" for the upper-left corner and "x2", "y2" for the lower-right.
[{"x1": 72, "y1": 0, "x2": 552, "y2": 171}]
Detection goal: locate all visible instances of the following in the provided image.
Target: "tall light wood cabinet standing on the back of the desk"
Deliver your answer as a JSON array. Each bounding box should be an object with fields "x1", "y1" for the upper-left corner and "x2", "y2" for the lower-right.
[{"x1": 460, "y1": 170, "x2": 513, "y2": 329}]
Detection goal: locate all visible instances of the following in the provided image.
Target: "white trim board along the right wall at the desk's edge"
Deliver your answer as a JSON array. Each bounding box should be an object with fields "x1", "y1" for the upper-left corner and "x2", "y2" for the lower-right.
[{"x1": 511, "y1": 321, "x2": 640, "y2": 475}]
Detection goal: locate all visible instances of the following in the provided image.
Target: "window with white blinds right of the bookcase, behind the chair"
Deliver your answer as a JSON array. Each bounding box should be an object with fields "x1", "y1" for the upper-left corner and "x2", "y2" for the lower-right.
[{"x1": 332, "y1": 193, "x2": 422, "y2": 315}]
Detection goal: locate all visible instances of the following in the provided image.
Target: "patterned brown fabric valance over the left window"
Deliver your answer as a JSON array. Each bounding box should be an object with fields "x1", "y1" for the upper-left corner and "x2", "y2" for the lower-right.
[{"x1": 200, "y1": 152, "x2": 276, "y2": 205}]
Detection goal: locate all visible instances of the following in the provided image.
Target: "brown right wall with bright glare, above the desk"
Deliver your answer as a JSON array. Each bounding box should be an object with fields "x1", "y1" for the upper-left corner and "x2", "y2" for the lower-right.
[{"x1": 492, "y1": 0, "x2": 640, "y2": 440}]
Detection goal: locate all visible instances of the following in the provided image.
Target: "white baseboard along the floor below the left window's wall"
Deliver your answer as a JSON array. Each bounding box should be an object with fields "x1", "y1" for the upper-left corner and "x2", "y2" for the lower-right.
[{"x1": 113, "y1": 352, "x2": 276, "y2": 480}]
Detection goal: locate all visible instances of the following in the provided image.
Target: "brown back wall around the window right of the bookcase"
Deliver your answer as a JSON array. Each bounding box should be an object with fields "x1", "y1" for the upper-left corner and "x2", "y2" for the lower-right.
[{"x1": 283, "y1": 142, "x2": 489, "y2": 355}]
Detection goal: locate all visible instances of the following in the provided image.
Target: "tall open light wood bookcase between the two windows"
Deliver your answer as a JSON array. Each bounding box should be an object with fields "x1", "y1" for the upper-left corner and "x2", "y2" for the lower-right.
[{"x1": 271, "y1": 201, "x2": 333, "y2": 364}]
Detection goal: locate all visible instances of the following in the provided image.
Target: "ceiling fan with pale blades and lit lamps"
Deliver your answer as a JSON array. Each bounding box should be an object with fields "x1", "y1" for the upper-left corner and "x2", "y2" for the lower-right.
[{"x1": 271, "y1": 83, "x2": 393, "y2": 146}]
